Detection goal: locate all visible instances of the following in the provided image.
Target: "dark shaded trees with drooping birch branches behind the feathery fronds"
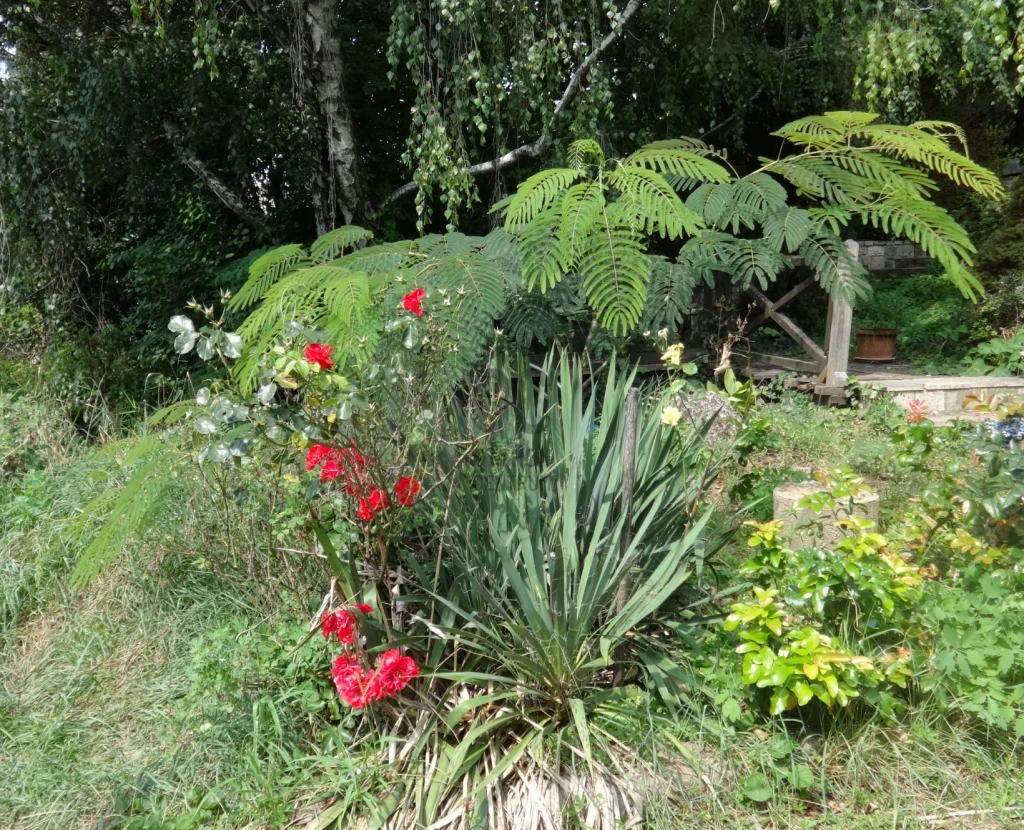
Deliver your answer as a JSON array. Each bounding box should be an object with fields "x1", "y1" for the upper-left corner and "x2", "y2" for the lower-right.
[{"x1": 0, "y1": 0, "x2": 1016, "y2": 411}]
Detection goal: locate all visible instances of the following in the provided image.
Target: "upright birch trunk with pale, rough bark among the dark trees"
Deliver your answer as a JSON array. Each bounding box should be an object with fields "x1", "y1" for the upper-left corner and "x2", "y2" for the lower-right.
[{"x1": 306, "y1": 0, "x2": 373, "y2": 227}]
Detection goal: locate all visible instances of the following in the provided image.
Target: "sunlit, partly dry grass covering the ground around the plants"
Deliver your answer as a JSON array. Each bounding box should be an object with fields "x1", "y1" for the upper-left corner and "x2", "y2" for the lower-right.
[{"x1": 0, "y1": 390, "x2": 1024, "y2": 830}]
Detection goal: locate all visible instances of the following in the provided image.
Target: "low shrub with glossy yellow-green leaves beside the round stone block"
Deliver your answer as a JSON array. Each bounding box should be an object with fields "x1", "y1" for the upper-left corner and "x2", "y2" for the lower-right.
[{"x1": 725, "y1": 476, "x2": 921, "y2": 715}]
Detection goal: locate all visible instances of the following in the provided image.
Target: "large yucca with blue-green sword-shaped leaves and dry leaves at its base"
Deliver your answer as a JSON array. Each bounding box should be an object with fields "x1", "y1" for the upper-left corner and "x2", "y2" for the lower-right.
[{"x1": 327, "y1": 356, "x2": 727, "y2": 828}]
